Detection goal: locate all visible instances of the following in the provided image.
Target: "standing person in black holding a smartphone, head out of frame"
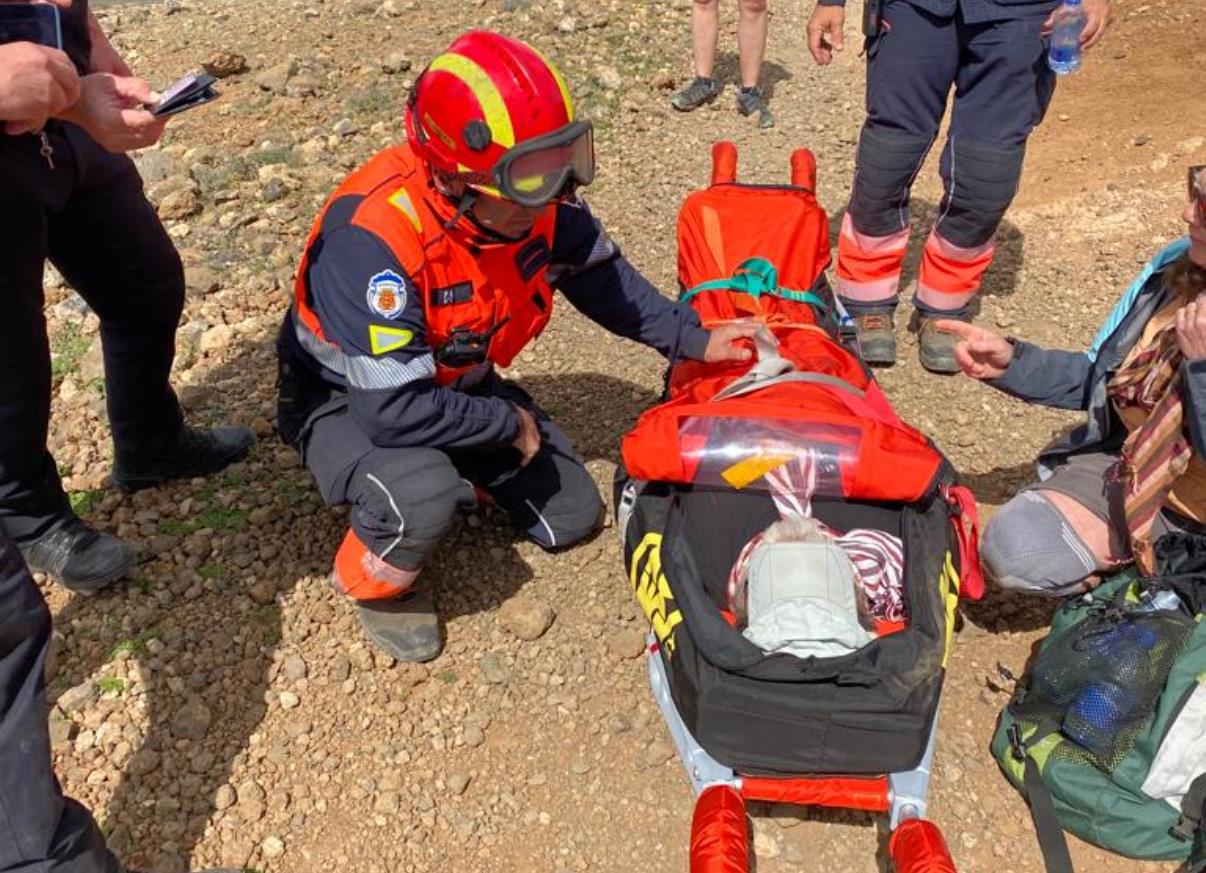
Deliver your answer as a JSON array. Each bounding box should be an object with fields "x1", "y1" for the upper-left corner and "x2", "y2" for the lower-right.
[{"x1": 0, "y1": 0, "x2": 253, "y2": 592}]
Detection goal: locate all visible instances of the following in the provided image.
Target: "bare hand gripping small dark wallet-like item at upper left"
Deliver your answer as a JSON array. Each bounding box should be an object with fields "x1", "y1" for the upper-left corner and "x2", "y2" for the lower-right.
[{"x1": 62, "y1": 72, "x2": 166, "y2": 152}]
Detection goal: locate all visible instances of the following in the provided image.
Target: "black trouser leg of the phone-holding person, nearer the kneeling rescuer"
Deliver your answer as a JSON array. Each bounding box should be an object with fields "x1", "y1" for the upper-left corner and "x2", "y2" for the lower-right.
[{"x1": 48, "y1": 128, "x2": 185, "y2": 463}]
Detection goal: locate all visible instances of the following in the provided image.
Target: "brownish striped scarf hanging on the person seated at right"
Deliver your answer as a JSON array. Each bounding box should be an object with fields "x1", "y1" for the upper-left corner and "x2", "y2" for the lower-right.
[{"x1": 1108, "y1": 323, "x2": 1193, "y2": 576}]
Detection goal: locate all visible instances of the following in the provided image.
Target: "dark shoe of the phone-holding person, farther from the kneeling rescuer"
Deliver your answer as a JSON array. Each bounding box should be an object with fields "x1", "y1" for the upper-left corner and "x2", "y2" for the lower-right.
[{"x1": 19, "y1": 516, "x2": 134, "y2": 594}]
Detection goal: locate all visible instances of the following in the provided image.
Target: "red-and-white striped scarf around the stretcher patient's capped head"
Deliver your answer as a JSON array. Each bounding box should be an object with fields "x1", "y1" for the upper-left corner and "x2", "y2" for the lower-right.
[{"x1": 727, "y1": 452, "x2": 907, "y2": 622}]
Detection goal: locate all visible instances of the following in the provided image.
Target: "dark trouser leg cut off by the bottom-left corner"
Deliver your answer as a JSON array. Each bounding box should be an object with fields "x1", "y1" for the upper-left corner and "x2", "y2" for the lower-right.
[{"x1": 0, "y1": 531, "x2": 121, "y2": 873}]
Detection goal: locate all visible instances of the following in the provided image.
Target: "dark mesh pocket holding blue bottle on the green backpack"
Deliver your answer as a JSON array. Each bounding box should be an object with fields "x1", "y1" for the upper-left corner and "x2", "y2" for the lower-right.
[{"x1": 1011, "y1": 605, "x2": 1194, "y2": 772}]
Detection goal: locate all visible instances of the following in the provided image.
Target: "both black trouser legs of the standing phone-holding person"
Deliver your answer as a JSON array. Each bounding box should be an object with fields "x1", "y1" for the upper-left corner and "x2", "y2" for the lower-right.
[{"x1": 0, "y1": 124, "x2": 185, "y2": 541}]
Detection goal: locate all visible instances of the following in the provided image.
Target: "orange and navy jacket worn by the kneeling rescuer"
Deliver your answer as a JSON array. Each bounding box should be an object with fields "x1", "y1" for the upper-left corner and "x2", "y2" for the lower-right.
[{"x1": 279, "y1": 145, "x2": 708, "y2": 449}]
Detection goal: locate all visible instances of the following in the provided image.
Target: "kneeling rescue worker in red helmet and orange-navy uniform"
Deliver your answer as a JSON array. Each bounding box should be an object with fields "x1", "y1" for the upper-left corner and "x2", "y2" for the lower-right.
[{"x1": 279, "y1": 31, "x2": 753, "y2": 661}]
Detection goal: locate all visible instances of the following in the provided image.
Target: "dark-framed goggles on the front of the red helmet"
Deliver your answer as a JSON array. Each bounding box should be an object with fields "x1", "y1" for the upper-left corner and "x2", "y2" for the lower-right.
[{"x1": 490, "y1": 122, "x2": 595, "y2": 207}]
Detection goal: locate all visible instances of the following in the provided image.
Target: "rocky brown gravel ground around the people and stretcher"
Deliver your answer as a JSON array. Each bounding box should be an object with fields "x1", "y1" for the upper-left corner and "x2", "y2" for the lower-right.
[{"x1": 35, "y1": 0, "x2": 1206, "y2": 873}]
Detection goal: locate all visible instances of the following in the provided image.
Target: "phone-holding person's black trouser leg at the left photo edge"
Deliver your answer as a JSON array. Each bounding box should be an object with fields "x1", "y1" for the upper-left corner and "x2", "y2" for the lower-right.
[{"x1": 0, "y1": 134, "x2": 75, "y2": 541}]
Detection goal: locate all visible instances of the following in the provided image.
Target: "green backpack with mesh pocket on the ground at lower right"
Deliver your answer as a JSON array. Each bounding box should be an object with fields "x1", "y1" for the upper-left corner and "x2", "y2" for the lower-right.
[{"x1": 993, "y1": 534, "x2": 1206, "y2": 873}]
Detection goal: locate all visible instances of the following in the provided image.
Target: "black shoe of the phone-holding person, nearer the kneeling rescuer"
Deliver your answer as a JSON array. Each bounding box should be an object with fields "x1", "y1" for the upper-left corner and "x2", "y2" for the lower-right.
[{"x1": 113, "y1": 424, "x2": 256, "y2": 493}]
